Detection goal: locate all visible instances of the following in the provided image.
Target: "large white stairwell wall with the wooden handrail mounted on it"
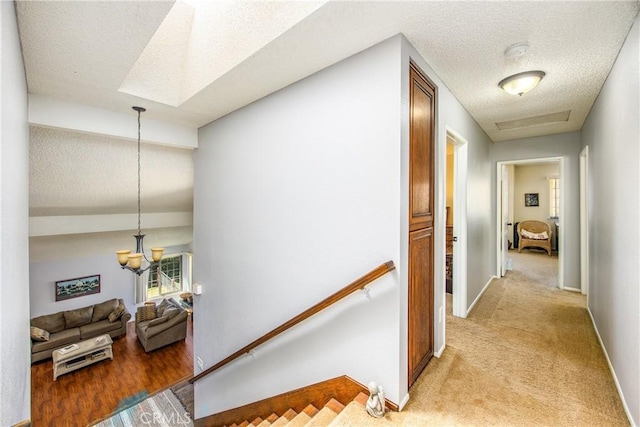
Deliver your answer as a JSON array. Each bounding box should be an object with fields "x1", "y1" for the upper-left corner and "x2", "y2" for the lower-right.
[{"x1": 194, "y1": 37, "x2": 406, "y2": 417}]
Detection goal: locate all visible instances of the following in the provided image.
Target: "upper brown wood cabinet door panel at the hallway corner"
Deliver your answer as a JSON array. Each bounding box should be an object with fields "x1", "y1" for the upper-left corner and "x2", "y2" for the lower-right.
[{"x1": 409, "y1": 64, "x2": 435, "y2": 231}]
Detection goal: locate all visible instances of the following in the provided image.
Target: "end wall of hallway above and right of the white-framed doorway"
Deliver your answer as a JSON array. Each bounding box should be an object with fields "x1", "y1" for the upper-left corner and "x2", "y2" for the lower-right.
[{"x1": 491, "y1": 132, "x2": 580, "y2": 289}]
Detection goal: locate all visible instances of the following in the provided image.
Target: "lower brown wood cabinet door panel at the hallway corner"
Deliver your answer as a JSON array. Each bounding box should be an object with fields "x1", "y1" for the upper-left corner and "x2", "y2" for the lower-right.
[{"x1": 408, "y1": 228, "x2": 433, "y2": 387}]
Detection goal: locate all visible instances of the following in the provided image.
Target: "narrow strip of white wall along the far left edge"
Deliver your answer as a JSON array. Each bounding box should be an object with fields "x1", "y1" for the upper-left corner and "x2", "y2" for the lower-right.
[{"x1": 0, "y1": 1, "x2": 31, "y2": 426}]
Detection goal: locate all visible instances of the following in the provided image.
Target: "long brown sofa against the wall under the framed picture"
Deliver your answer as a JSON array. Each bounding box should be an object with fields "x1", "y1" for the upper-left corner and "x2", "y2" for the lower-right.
[{"x1": 31, "y1": 298, "x2": 131, "y2": 363}]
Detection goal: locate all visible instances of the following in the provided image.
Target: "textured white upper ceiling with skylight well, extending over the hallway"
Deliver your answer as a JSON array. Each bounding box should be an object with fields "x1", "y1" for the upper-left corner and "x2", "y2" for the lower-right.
[{"x1": 17, "y1": 1, "x2": 638, "y2": 141}]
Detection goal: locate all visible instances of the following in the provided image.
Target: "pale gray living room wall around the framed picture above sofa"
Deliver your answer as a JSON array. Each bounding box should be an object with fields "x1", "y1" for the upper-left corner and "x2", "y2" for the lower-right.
[{"x1": 29, "y1": 244, "x2": 189, "y2": 318}]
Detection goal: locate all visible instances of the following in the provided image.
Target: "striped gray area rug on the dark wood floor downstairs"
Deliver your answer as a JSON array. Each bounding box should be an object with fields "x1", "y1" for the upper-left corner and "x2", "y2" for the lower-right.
[{"x1": 94, "y1": 389, "x2": 193, "y2": 427}]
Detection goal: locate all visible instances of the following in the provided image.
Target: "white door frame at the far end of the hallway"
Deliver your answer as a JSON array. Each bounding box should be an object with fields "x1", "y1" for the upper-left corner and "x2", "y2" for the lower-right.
[{"x1": 495, "y1": 156, "x2": 567, "y2": 289}]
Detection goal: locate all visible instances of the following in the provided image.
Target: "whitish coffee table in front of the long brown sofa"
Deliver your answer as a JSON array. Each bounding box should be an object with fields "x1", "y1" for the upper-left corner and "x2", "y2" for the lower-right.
[{"x1": 52, "y1": 334, "x2": 113, "y2": 381}]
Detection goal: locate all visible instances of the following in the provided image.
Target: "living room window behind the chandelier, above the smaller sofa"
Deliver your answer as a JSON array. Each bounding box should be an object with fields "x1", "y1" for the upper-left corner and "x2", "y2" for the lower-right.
[{"x1": 147, "y1": 254, "x2": 191, "y2": 300}]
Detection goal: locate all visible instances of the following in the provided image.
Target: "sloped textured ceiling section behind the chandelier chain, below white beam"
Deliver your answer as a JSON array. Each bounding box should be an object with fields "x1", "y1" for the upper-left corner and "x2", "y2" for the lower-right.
[{"x1": 29, "y1": 127, "x2": 193, "y2": 216}]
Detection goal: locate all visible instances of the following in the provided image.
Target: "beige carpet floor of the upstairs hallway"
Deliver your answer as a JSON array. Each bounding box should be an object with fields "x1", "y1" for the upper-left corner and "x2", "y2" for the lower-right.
[{"x1": 386, "y1": 251, "x2": 629, "y2": 426}]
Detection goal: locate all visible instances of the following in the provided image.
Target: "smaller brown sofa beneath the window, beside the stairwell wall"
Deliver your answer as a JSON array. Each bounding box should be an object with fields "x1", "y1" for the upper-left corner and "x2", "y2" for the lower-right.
[{"x1": 136, "y1": 298, "x2": 188, "y2": 353}]
